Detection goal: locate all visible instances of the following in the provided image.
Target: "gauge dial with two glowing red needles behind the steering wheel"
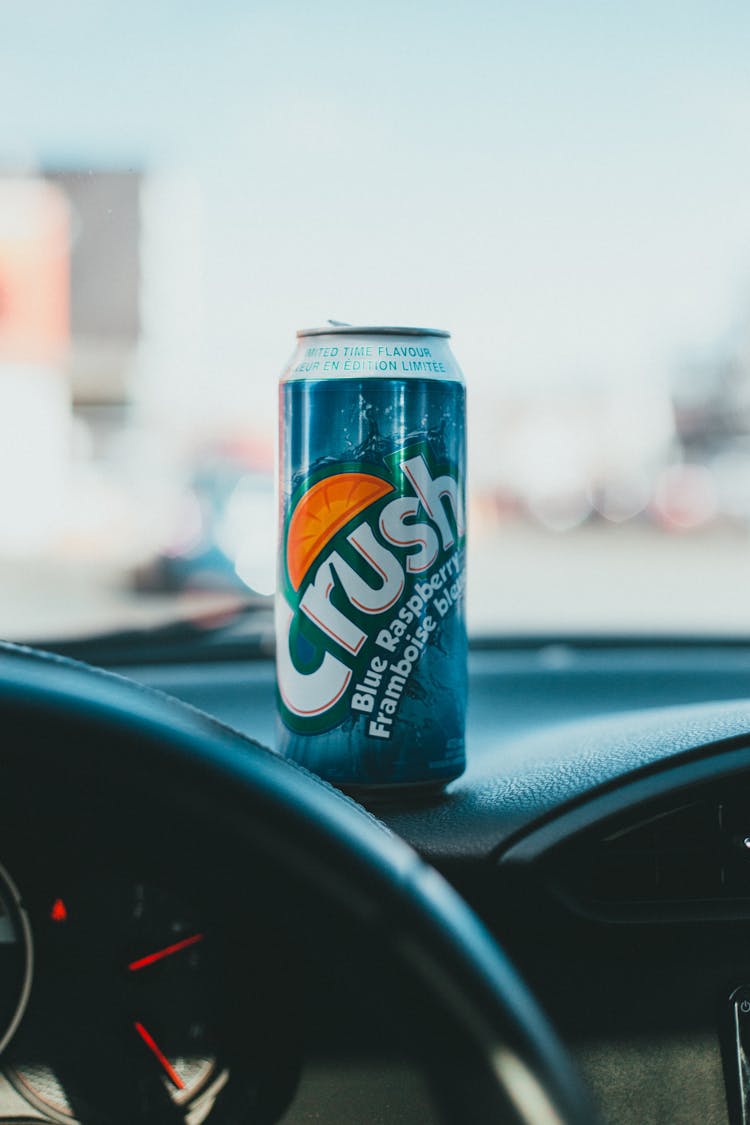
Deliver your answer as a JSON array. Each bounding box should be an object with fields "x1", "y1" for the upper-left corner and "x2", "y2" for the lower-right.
[{"x1": 5, "y1": 881, "x2": 228, "y2": 1125}]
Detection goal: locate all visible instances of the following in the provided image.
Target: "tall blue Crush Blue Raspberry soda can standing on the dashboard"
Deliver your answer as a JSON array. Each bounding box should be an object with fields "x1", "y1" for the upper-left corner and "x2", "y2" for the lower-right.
[{"x1": 275, "y1": 324, "x2": 467, "y2": 794}]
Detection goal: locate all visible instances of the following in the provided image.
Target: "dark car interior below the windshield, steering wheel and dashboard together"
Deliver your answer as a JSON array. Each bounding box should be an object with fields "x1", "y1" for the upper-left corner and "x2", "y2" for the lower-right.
[{"x1": 2, "y1": 630, "x2": 750, "y2": 1123}]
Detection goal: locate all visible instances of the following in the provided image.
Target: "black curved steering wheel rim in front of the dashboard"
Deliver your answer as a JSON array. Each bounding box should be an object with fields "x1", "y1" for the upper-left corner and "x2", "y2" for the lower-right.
[{"x1": 0, "y1": 645, "x2": 594, "y2": 1125}]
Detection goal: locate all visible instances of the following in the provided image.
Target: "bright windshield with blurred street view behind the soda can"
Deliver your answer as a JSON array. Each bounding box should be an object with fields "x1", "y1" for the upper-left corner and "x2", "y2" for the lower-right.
[{"x1": 0, "y1": 0, "x2": 750, "y2": 640}]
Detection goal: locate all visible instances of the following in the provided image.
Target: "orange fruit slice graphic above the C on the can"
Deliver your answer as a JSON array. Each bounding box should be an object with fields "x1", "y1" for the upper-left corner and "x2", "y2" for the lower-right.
[{"x1": 287, "y1": 473, "x2": 394, "y2": 590}]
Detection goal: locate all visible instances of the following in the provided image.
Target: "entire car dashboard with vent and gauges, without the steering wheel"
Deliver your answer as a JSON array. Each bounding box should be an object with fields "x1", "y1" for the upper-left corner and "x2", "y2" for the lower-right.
[{"x1": 7, "y1": 640, "x2": 750, "y2": 1125}]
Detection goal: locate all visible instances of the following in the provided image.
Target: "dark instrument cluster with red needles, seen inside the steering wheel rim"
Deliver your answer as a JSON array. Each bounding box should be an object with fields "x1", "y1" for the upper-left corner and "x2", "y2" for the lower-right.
[{"x1": 0, "y1": 849, "x2": 293, "y2": 1125}]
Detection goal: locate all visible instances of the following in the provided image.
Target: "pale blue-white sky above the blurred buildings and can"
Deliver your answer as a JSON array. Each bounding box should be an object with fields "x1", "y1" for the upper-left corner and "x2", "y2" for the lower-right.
[{"x1": 0, "y1": 0, "x2": 750, "y2": 424}]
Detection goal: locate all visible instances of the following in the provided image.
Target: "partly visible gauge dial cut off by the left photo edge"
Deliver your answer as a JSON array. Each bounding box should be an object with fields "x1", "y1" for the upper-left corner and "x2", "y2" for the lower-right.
[{"x1": 0, "y1": 867, "x2": 33, "y2": 1052}]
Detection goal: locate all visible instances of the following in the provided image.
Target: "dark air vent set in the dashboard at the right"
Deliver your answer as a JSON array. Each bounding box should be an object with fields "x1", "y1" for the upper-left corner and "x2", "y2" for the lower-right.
[{"x1": 558, "y1": 789, "x2": 750, "y2": 908}]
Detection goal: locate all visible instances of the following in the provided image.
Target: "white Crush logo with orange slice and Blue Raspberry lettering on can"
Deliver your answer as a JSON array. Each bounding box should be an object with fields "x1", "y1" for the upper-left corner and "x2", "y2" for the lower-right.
[{"x1": 277, "y1": 442, "x2": 464, "y2": 739}]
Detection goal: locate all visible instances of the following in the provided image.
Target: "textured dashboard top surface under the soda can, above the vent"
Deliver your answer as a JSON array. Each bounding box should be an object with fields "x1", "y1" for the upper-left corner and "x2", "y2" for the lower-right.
[{"x1": 123, "y1": 642, "x2": 750, "y2": 865}]
